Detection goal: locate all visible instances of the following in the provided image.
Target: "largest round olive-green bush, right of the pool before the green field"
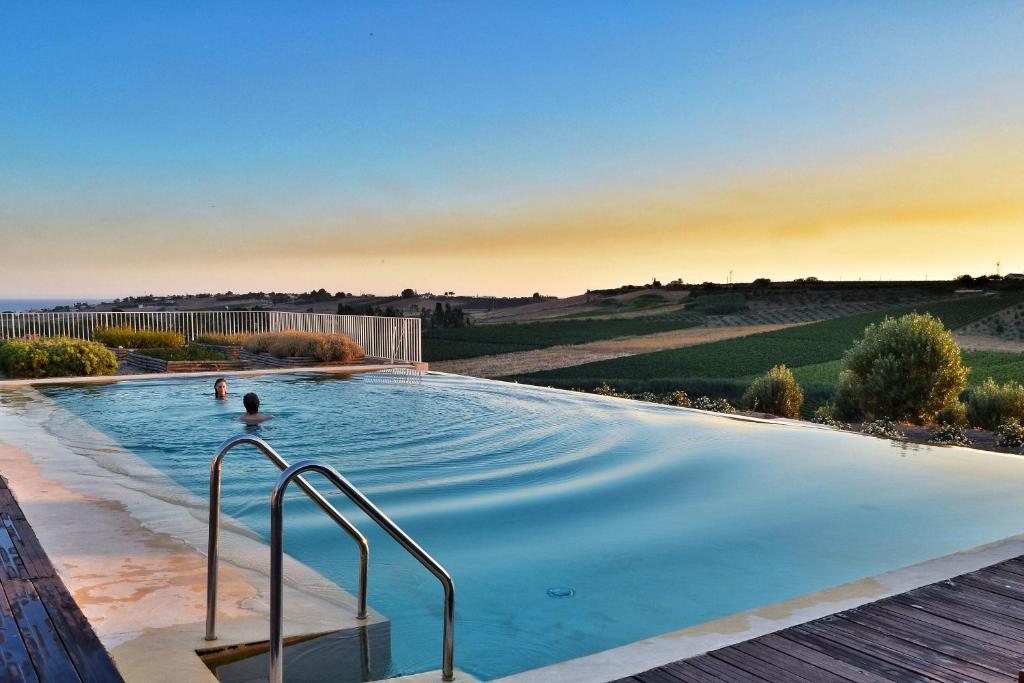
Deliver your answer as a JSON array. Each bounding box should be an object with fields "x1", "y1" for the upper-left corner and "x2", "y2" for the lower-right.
[{"x1": 836, "y1": 313, "x2": 968, "y2": 423}]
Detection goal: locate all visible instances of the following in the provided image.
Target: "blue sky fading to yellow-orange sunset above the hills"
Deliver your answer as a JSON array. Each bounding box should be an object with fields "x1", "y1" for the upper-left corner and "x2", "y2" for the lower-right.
[{"x1": 0, "y1": 0, "x2": 1024, "y2": 298}]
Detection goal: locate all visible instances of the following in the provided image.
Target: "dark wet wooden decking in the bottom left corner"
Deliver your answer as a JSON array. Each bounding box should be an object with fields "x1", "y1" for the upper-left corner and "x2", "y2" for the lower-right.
[{"x1": 0, "y1": 477, "x2": 122, "y2": 683}]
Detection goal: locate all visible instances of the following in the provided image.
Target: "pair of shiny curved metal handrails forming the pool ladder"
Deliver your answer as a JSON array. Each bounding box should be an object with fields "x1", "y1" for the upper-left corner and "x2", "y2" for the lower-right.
[{"x1": 206, "y1": 434, "x2": 455, "y2": 683}]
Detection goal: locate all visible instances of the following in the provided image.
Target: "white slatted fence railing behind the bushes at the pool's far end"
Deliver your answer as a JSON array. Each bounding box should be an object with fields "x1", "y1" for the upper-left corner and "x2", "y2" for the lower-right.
[{"x1": 0, "y1": 310, "x2": 422, "y2": 362}]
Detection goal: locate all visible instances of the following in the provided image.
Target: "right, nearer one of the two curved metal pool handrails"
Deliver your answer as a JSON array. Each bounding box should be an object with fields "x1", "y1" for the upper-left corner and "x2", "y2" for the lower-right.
[{"x1": 270, "y1": 460, "x2": 455, "y2": 683}]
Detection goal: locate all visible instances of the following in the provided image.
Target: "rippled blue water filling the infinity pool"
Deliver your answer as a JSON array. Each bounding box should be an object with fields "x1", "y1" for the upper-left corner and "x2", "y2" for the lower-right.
[{"x1": 41, "y1": 374, "x2": 1024, "y2": 679}]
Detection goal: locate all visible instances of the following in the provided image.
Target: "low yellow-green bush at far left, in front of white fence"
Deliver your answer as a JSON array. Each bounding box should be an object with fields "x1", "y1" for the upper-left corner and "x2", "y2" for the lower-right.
[{"x1": 0, "y1": 337, "x2": 118, "y2": 379}]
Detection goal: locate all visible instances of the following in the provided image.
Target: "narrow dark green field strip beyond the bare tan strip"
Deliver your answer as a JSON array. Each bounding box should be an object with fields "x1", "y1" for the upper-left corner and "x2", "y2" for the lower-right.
[{"x1": 423, "y1": 315, "x2": 703, "y2": 362}]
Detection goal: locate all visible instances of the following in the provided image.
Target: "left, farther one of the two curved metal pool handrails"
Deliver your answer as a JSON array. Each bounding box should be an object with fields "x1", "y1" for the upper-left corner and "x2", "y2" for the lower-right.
[{"x1": 206, "y1": 434, "x2": 370, "y2": 640}]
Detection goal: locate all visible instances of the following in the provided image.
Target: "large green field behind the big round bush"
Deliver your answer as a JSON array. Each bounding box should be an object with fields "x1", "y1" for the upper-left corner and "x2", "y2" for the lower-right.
[{"x1": 510, "y1": 295, "x2": 1024, "y2": 402}]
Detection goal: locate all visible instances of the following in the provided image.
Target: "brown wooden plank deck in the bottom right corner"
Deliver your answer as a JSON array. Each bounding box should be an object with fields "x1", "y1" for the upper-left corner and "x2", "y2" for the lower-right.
[{"x1": 618, "y1": 557, "x2": 1024, "y2": 683}]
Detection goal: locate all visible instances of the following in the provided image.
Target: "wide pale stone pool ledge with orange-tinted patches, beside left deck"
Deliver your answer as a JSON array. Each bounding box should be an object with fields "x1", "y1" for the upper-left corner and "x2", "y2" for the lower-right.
[{"x1": 0, "y1": 385, "x2": 390, "y2": 683}]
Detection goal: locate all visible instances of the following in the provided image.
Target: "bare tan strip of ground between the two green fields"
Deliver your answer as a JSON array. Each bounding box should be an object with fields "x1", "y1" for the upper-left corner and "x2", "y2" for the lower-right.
[{"x1": 430, "y1": 323, "x2": 804, "y2": 377}]
